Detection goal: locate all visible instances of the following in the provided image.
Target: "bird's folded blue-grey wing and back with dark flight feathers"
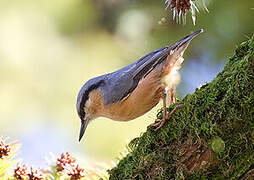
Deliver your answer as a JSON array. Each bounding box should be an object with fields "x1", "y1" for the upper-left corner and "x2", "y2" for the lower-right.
[{"x1": 101, "y1": 47, "x2": 168, "y2": 104}]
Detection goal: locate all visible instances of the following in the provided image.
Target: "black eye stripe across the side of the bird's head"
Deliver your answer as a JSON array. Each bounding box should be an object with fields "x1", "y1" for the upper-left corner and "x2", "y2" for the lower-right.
[{"x1": 78, "y1": 80, "x2": 104, "y2": 119}]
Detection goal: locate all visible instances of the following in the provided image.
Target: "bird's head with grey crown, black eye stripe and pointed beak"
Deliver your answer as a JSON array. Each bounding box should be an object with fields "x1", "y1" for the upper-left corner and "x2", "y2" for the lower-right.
[{"x1": 76, "y1": 79, "x2": 103, "y2": 141}]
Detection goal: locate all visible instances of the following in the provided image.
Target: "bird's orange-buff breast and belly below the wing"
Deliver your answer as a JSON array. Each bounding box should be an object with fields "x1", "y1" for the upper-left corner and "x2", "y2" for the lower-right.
[{"x1": 92, "y1": 65, "x2": 164, "y2": 121}]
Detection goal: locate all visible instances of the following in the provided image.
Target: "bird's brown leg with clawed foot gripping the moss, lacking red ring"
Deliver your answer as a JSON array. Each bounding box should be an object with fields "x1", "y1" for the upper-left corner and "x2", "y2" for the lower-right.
[{"x1": 151, "y1": 93, "x2": 184, "y2": 131}]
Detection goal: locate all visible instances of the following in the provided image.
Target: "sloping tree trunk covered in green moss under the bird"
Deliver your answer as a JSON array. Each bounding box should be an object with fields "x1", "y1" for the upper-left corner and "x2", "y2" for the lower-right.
[{"x1": 109, "y1": 36, "x2": 254, "y2": 180}]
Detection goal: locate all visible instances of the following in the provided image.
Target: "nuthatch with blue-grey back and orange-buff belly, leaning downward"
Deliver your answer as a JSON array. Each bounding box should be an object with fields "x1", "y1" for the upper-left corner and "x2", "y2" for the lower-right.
[{"x1": 76, "y1": 29, "x2": 203, "y2": 141}]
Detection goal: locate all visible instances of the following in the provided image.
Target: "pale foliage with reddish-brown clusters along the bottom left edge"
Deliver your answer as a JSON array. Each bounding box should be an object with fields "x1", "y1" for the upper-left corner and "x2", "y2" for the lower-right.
[{"x1": 0, "y1": 137, "x2": 109, "y2": 180}]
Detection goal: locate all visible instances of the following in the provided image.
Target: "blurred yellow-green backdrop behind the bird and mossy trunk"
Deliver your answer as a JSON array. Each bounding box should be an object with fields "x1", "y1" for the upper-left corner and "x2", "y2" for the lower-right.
[{"x1": 0, "y1": 0, "x2": 254, "y2": 166}]
